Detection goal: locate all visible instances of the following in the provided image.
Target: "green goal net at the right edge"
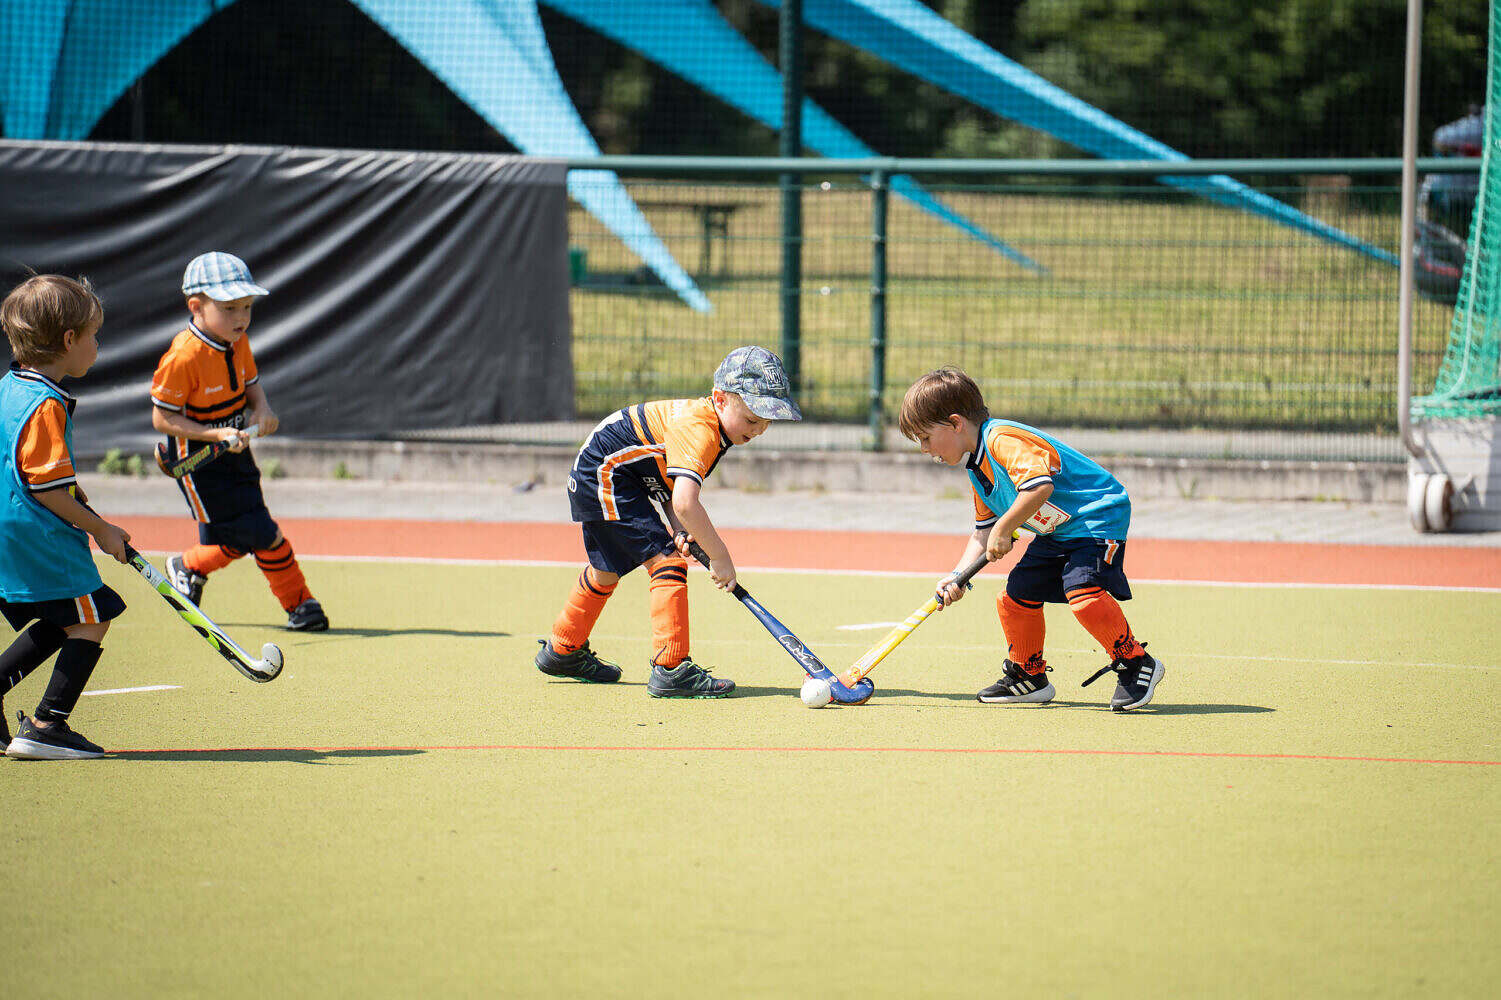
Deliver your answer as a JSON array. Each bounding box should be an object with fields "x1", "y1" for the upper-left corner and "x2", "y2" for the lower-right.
[{"x1": 1412, "y1": 4, "x2": 1501, "y2": 419}]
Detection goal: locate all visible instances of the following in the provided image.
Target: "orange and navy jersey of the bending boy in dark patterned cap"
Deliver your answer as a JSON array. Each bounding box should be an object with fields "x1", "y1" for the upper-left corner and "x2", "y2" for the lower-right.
[{"x1": 567, "y1": 396, "x2": 729, "y2": 521}]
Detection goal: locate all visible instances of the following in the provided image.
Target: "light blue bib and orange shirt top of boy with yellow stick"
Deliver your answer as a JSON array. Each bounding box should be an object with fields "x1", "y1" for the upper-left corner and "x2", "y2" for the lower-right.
[{"x1": 964, "y1": 417, "x2": 1130, "y2": 541}]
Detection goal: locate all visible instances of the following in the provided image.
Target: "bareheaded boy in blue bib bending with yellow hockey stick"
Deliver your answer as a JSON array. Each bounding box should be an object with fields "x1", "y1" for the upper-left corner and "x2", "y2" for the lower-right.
[{"x1": 901, "y1": 368, "x2": 1163, "y2": 712}]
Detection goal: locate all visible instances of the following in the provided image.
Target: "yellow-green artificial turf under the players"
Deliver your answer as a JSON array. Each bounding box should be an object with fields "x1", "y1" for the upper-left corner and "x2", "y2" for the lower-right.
[{"x1": 0, "y1": 562, "x2": 1501, "y2": 997}]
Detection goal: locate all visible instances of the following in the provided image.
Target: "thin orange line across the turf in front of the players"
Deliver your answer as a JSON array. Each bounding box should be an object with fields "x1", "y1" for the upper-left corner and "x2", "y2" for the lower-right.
[{"x1": 110, "y1": 743, "x2": 1501, "y2": 767}]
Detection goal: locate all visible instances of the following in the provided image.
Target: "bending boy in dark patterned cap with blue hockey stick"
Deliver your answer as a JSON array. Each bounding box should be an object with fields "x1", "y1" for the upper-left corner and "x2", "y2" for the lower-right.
[{"x1": 534, "y1": 347, "x2": 803, "y2": 698}]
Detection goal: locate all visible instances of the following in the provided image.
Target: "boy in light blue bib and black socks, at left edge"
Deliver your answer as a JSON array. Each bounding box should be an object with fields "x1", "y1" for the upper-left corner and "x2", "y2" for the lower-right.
[{"x1": 0, "y1": 275, "x2": 131, "y2": 760}]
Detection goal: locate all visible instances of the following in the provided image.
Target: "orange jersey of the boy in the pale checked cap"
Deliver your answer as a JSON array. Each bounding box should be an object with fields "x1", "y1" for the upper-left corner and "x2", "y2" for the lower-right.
[{"x1": 152, "y1": 323, "x2": 261, "y2": 428}]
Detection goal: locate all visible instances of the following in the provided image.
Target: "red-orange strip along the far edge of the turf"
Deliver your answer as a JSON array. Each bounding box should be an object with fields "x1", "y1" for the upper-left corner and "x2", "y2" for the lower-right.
[{"x1": 119, "y1": 517, "x2": 1501, "y2": 589}]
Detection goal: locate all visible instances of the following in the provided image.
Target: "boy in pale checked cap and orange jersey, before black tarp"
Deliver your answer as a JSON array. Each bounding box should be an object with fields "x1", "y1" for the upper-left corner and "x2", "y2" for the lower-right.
[{"x1": 152, "y1": 251, "x2": 329, "y2": 632}]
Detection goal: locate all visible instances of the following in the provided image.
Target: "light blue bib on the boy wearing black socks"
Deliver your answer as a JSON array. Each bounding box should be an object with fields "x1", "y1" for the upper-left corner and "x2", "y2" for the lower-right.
[{"x1": 0, "y1": 366, "x2": 104, "y2": 602}]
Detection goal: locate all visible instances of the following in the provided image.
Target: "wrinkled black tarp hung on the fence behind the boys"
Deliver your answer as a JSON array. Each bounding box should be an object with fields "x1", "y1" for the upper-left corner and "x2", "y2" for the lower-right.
[{"x1": 0, "y1": 141, "x2": 573, "y2": 455}]
